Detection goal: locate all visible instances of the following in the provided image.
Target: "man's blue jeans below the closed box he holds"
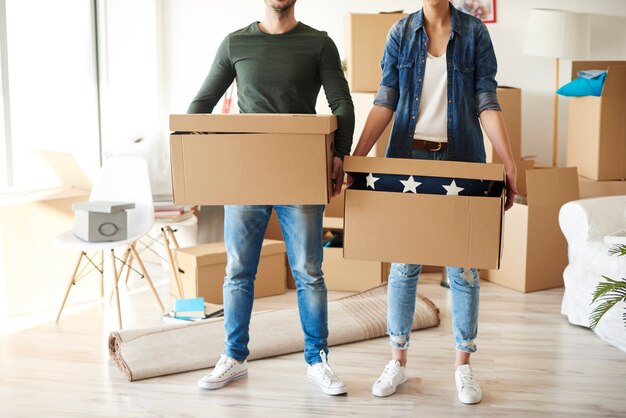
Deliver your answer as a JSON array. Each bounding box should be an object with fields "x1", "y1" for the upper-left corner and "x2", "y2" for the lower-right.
[{"x1": 224, "y1": 205, "x2": 328, "y2": 364}]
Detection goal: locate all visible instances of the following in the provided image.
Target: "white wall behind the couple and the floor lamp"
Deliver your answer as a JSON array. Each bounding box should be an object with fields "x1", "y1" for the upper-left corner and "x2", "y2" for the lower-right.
[{"x1": 161, "y1": 0, "x2": 626, "y2": 165}]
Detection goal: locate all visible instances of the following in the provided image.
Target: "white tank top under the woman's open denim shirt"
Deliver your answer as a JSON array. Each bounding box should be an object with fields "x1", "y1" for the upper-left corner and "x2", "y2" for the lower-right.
[{"x1": 413, "y1": 54, "x2": 448, "y2": 142}]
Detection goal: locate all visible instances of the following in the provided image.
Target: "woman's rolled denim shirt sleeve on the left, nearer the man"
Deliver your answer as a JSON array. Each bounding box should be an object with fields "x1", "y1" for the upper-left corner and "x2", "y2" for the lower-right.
[{"x1": 374, "y1": 23, "x2": 400, "y2": 111}]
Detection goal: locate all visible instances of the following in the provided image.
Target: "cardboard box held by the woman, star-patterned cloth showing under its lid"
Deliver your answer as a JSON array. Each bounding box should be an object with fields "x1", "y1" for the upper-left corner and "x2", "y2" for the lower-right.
[{"x1": 344, "y1": 157, "x2": 504, "y2": 268}]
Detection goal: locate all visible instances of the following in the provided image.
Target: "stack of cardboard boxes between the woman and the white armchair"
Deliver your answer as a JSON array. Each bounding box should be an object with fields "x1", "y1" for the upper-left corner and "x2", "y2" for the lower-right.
[{"x1": 480, "y1": 87, "x2": 579, "y2": 292}]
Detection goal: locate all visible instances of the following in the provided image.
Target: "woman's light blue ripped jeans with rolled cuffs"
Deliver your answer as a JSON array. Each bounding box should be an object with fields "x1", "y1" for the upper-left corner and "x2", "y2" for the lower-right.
[{"x1": 387, "y1": 150, "x2": 480, "y2": 353}]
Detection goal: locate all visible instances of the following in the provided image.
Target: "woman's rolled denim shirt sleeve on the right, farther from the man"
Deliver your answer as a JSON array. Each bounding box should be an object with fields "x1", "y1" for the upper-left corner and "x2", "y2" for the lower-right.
[{"x1": 474, "y1": 22, "x2": 501, "y2": 114}]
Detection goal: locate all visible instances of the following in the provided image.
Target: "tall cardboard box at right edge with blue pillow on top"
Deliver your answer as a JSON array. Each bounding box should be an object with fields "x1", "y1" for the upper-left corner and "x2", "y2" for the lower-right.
[{"x1": 567, "y1": 61, "x2": 626, "y2": 180}]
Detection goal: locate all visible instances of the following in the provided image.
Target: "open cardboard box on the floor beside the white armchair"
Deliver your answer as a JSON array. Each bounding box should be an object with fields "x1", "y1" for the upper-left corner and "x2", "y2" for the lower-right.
[{"x1": 481, "y1": 167, "x2": 578, "y2": 292}]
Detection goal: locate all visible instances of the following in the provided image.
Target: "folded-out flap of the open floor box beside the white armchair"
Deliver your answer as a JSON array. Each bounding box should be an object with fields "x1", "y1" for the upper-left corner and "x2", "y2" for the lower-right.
[{"x1": 526, "y1": 167, "x2": 579, "y2": 207}]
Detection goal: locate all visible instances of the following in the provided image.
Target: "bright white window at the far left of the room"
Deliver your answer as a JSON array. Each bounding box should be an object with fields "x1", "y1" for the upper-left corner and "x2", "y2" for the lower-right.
[{"x1": 0, "y1": 0, "x2": 100, "y2": 189}]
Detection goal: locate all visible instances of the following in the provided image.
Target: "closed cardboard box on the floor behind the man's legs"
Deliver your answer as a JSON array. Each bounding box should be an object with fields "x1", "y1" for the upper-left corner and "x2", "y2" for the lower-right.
[{"x1": 174, "y1": 240, "x2": 287, "y2": 304}]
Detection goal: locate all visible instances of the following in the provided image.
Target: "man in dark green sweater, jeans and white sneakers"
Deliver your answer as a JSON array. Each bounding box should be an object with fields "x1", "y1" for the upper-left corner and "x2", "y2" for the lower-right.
[{"x1": 188, "y1": 0, "x2": 354, "y2": 395}]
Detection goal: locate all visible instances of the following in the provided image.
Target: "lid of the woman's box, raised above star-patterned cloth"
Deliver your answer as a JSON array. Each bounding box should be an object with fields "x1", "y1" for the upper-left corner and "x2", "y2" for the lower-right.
[{"x1": 344, "y1": 157, "x2": 505, "y2": 181}]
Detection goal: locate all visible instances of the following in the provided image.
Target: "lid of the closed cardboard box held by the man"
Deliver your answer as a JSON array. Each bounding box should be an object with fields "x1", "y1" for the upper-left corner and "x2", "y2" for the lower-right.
[{"x1": 170, "y1": 113, "x2": 337, "y2": 134}]
